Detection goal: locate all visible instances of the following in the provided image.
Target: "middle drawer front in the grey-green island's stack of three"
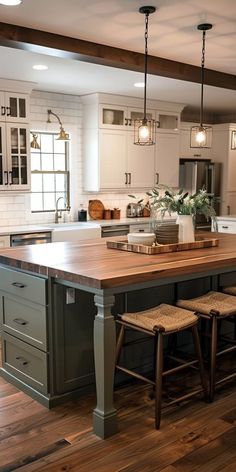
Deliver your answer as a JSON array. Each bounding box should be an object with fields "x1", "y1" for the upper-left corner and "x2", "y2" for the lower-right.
[{"x1": 1, "y1": 293, "x2": 47, "y2": 351}]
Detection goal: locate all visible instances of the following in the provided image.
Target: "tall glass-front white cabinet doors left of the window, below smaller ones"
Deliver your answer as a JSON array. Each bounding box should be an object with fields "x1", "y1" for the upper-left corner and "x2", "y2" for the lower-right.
[{"x1": 0, "y1": 123, "x2": 30, "y2": 190}]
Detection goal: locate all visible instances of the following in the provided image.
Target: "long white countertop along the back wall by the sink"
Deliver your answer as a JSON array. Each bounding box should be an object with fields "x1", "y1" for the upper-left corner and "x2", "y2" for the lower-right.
[{"x1": 0, "y1": 217, "x2": 176, "y2": 236}]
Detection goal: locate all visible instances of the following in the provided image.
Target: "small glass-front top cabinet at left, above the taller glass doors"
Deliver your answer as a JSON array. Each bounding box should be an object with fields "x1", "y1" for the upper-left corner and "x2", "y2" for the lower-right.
[{"x1": 0, "y1": 92, "x2": 29, "y2": 123}]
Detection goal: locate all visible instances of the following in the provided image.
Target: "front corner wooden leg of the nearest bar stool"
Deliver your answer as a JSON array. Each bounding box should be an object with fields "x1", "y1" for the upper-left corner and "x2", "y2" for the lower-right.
[{"x1": 155, "y1": 332, "x2": 163, "y2": 429}]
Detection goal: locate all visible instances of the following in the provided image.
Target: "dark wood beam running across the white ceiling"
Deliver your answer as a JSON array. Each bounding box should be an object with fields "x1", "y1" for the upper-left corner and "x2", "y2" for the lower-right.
[{"x1": 0, "y1": 23, "x2": 236, "y2": 90}]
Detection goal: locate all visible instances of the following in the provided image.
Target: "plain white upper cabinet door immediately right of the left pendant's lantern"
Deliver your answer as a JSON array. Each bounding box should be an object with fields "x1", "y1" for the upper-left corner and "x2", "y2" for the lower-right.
[{"x1": 156, "y1": 133, "x2": 179, "y2": 187}]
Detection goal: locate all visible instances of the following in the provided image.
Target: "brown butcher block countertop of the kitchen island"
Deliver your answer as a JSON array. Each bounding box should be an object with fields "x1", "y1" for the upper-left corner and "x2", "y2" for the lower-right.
[{"x1": 0, "y1": 233, "x2": 236, "y2": 289}]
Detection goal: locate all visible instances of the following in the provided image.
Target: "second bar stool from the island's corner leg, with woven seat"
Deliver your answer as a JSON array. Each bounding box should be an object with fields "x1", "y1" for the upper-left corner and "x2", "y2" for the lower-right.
[{"x1": 176, "y1": 291, "x2": 236, "y2": 402}]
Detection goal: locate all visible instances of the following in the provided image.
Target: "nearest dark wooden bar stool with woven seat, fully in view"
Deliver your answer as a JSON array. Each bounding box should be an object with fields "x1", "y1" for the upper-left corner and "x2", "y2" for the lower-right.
[{"x1": 116, "y1": 303, "x2": 207, "y2": 429}]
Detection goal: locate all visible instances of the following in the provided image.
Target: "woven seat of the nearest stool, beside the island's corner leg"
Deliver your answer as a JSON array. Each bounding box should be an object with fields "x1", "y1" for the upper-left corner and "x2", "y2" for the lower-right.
[{"x1": 121, "y1": 303, "x2": 197, "y2": 332}]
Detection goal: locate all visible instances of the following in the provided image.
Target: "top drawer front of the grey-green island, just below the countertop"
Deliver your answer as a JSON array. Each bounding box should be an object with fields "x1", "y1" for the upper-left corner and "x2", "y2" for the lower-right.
[{"x1": 0, "y1": 267, "x2": 46, "y2": 305}]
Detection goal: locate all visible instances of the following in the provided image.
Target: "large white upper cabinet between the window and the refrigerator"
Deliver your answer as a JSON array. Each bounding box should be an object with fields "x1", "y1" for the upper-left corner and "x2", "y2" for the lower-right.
[{"x1": 82, "y1": 94, "x2": 183, "y2": 192}]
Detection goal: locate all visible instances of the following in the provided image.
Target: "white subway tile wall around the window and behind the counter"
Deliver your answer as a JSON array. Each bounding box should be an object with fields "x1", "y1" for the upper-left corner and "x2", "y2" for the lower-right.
[{"x1": 0, "y1": 90, "x2": 145, "y2": 226}]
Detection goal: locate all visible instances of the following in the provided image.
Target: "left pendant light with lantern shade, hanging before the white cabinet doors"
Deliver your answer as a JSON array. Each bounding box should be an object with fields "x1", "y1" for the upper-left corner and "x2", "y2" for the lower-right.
[{"x1": 134, "y1": 6, "x2": 156, "y2": 146}]
